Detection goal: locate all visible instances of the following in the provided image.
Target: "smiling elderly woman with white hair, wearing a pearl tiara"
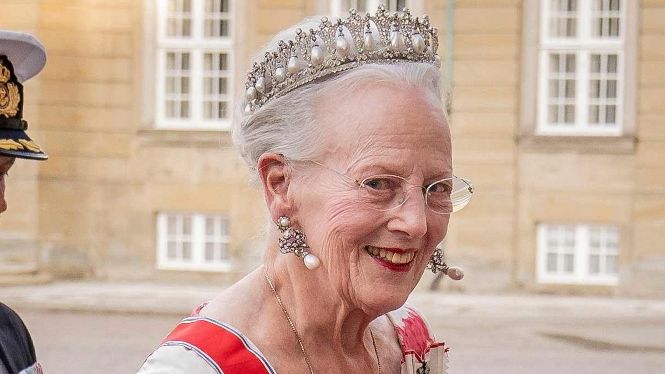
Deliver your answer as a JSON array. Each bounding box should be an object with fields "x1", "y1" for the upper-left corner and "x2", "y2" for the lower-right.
[{"x1": 140, "y1": 9, "x2": 472, "y2": 373}]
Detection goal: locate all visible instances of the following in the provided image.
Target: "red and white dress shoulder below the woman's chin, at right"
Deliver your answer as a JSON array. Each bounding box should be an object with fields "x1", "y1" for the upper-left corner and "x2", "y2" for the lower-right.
[{"x1": 388, "y1": 306, "x2": 444, "y2": 361}]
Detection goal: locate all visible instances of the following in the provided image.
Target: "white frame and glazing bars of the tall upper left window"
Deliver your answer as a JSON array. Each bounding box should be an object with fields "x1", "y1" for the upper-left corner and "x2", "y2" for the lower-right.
[{"x1": 155, "y1": 0, "x2": 237, "y2": 130}]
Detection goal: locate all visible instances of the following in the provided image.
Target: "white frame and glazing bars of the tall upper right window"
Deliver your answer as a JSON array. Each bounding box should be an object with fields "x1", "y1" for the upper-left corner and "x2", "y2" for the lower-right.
[{"x1": 536, "y1": 0, "x2": 630, "y2": 136}]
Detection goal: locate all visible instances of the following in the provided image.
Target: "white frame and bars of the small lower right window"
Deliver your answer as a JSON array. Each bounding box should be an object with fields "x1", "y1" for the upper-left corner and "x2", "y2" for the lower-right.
[{"x1": 536, "y1": 223, "x2": 621, "y2": 286}]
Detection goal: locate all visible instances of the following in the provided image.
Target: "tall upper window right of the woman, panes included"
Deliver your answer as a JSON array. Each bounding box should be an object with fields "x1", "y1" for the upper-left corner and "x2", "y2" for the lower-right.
[{"x1": 537, "y1": 0, "x2": 626, "y2": 135}]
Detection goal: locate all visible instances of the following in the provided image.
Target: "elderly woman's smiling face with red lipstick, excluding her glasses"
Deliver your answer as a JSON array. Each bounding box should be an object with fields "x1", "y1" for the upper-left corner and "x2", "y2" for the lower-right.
[{"x1": 295, "y1": 85, "x2": 452, "y2": 314}]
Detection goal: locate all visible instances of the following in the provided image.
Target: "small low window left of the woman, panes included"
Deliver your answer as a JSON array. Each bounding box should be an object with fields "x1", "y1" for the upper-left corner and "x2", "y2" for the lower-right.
[{"x1": 157, "y1": 213, "x2": 231, "y2": 271}]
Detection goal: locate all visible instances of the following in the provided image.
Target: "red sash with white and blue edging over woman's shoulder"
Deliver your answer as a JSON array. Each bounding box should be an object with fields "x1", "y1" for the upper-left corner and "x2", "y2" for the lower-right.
[{"x1": 161, "y1": 317, "x2": 275, "y2": 374}]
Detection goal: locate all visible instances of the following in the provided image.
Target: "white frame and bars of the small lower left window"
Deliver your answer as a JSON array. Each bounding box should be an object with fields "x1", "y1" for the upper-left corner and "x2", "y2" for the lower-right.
[{"x1": 156, "y1": 212, "x2": 232, "y2": 272}]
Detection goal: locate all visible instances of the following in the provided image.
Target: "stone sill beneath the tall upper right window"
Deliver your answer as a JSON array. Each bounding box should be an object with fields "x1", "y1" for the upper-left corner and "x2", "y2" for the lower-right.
[{"x1": 516, "y1": 135, "x2": 638, "y2": 154}]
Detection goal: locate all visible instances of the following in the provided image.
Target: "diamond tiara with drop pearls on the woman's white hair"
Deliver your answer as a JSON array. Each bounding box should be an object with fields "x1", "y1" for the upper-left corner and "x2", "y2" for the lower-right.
[{"x1": 245, "y1": 6, "x2": 441, "y2": 114}]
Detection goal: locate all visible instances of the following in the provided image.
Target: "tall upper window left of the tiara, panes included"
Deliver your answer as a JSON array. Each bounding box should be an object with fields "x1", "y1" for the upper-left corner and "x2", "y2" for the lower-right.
[{"x1": 155, "y1": 0, "x2": 233, "y2": 130}]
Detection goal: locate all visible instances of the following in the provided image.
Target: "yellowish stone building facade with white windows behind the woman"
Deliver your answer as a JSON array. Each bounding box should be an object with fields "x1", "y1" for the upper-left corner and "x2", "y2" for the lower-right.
[{"x1": 0, "y1": 0, "x2": 665, "y2": 296}]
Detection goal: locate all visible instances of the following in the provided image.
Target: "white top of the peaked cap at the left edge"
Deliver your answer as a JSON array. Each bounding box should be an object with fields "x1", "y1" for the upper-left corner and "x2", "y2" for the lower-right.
[{"x1": 0, "y1": 30, "x2": 46, "y2": 83}]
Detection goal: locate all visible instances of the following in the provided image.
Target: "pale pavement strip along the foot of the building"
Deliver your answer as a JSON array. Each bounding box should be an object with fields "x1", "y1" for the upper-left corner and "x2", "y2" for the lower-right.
[{"x1": 0, "y1": 281, "x2": 665, "y2": 352}]
